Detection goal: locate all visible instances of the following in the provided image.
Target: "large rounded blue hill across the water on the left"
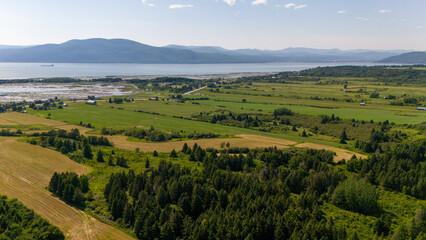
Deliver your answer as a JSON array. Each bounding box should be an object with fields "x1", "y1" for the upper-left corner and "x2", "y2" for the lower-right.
[{"x1": 0, "y1": 39, "x2": 267, "y2": 63}]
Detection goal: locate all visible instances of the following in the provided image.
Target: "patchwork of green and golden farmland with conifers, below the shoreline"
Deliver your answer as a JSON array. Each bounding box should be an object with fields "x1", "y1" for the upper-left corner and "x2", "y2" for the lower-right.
[{"x1": 0, "y1": 64, "x2": 426, "y2": 239}]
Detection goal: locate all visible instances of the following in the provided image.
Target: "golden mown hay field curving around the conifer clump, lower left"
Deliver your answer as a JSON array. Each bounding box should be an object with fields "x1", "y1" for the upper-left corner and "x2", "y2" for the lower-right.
[{"x1": 0, "y1": 138, "x2": 133, "y2": 240}]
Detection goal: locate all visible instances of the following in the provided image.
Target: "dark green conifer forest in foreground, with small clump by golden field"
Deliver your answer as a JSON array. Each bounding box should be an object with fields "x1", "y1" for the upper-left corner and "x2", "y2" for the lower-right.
[{"x1": 49, "y1": 137, "x2": 426, "y2": 239}]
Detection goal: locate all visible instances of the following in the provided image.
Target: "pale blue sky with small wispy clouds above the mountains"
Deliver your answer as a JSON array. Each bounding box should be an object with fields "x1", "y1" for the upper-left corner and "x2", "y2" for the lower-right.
[{"x1": 0, "y1": 0, "x2": 426, "y2": 51}]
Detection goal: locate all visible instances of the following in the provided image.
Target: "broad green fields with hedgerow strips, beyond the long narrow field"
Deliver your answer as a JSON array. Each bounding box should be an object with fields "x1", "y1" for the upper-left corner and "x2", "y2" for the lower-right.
[{"x1": 100, "y1": 77, "x2": 426, "y2": 124}]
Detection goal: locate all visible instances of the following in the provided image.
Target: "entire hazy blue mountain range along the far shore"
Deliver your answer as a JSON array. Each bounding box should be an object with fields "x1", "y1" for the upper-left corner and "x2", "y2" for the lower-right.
[{"x1": 0, "y1": 38, "x2": 420, "y2": 64}]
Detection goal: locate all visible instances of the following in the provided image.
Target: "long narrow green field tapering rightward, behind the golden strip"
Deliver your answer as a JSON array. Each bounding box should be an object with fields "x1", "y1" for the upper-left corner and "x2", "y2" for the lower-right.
[{"x1": 28, "y1": 103, "x2": 356, "y2": 148}]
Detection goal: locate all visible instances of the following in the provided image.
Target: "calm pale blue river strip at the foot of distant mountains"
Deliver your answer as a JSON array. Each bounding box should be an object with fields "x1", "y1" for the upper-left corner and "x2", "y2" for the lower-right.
[{"x1": 0, "y1": 62, "x2": 390, "y2": 80}]
